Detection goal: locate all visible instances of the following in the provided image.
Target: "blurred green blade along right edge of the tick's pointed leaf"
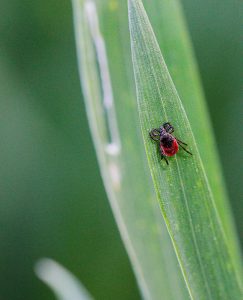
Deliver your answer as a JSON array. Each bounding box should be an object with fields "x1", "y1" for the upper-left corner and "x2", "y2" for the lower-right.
[{"x1": 143, "y1": 0, "x2": 243, "y2": 272}]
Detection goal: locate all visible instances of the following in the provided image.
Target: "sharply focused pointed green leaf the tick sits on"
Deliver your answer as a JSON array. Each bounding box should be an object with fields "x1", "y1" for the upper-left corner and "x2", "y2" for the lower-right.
[{"x1": 128, "y1": 0, "x2": 242, "y2": 299}]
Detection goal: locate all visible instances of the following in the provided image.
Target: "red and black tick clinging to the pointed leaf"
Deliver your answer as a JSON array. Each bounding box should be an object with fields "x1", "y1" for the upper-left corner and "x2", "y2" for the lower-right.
[{"x1": 149, "y1": 122, "x2": 192, "y2": 165}]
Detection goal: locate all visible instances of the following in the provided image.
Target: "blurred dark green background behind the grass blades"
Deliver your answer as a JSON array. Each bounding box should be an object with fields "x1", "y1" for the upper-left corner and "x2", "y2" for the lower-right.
[{"x1": 0, "y1": 0, "x2": 243, "y2": 300}]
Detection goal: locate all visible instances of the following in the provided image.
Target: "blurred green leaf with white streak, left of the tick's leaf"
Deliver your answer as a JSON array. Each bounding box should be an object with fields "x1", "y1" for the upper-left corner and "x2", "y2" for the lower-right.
[{"x1": 73, "y1": 0, "x2": 189, "y2": 300}]
